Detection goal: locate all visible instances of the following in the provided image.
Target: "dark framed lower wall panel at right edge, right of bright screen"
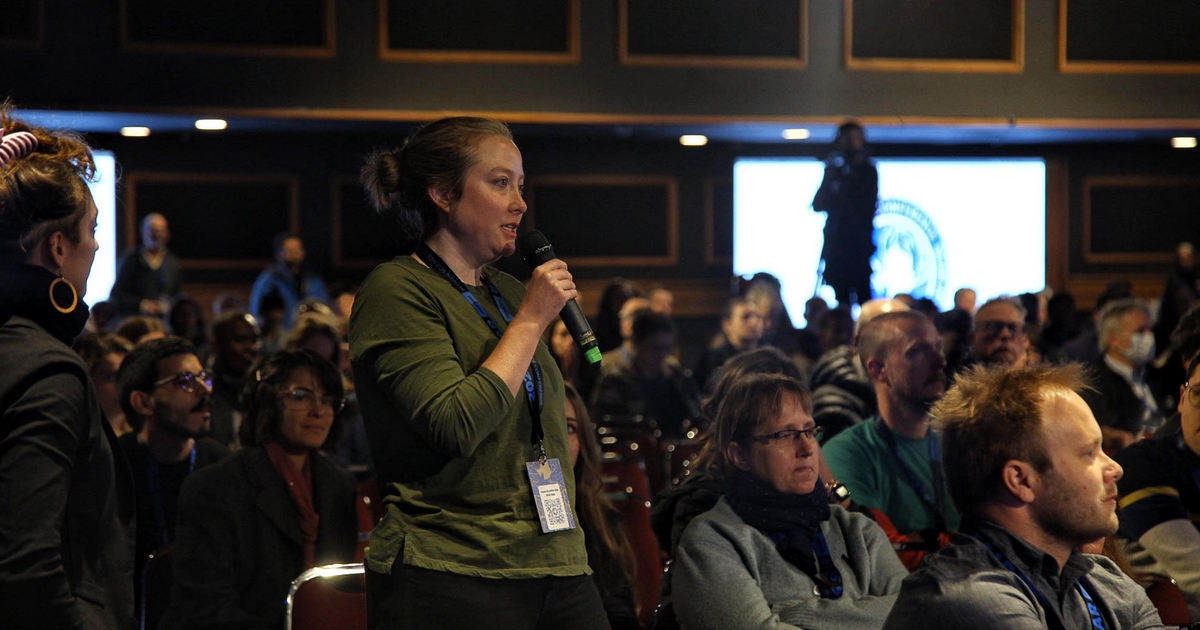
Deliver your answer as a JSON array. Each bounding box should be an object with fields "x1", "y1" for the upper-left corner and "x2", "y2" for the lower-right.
[{"x1": 1082, "y1": 175, "x2": 1200, "y2": 264}]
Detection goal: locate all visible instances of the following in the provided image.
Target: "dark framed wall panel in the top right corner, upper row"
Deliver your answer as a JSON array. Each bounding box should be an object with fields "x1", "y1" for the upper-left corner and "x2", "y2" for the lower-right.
[{"x1": 1058, "y1": 0, "x2": 1200, "y2": 73}]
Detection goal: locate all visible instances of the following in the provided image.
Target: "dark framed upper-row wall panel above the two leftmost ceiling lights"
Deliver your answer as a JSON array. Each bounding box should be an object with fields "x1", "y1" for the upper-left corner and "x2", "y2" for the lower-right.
[{"x1": 120, "y1": 0, "x2": 335, "y2": 56}]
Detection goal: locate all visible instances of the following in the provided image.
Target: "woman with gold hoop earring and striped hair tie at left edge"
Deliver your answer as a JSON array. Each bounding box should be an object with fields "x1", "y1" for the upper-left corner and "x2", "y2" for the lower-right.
[{"x1": 0, "y1": 103, "x2": 133, "y2": 629}]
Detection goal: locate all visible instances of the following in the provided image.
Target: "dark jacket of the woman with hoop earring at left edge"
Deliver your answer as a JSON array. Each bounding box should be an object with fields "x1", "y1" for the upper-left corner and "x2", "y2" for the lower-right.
[{"x1": 0, "y1": 316, "x2": 133, "y2": 630}]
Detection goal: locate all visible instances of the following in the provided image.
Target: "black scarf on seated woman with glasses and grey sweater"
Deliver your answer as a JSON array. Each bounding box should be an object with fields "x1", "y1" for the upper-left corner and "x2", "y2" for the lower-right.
[{"x1": 725, "y1": 472, "x2": 830, "y2": 584}]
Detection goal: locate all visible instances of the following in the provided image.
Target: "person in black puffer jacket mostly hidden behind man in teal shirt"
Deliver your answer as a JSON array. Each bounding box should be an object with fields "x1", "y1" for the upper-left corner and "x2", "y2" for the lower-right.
[{"x1": 809, "y1": 299, "x2": 908, "y2": 440}]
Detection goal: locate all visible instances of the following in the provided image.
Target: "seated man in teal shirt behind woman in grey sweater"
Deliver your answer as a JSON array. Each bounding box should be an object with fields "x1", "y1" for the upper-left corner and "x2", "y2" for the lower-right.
[{"x1": 823, "y1": 311, "x2": 959, "y2": 568}]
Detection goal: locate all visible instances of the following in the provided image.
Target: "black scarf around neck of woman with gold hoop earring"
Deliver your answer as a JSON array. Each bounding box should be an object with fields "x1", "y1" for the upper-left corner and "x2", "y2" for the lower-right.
[{"x1": 0, "y1": 263, "x2": 88, "y2": 346}]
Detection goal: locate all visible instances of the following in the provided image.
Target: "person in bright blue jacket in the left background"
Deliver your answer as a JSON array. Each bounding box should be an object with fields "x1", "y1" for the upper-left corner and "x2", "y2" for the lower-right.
[{"x1": 250, "y1": 234, "x2": 329, "y2": 331}]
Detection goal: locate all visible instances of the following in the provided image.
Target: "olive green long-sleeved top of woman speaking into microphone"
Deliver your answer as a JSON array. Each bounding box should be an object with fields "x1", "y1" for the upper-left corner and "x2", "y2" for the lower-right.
[{"x1": 350, "y1": 257, "x2": 590, "y2": 577}]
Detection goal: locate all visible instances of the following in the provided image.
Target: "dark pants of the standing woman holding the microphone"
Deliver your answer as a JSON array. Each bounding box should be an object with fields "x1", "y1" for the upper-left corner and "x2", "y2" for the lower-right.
[{"x1": 367, "y1": 562, "x2": 608, "y2": 630}]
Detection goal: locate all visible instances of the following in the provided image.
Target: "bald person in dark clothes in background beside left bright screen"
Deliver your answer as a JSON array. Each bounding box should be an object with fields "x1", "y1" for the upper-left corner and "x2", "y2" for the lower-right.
[{"x1": 110, "y1": 212, "x2": 181, "y2": 318}]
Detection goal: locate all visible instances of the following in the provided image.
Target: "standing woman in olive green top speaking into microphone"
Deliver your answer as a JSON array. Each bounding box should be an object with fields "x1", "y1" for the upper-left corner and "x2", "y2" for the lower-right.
[{"x1": 350, "y1": 118, "x2": 607, "y2": 630}]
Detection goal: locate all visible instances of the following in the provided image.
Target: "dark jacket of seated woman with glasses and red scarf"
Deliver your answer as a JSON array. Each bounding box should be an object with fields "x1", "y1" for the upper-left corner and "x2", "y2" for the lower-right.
[{"x1": 158, "y1": 446, "x2": 358, "y2": 630}]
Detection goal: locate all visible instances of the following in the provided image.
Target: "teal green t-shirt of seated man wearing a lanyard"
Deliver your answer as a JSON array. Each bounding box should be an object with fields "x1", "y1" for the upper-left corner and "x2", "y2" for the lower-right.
[{"x1": 821, "y1": 416, "x2": 959, "y2": 534}]
